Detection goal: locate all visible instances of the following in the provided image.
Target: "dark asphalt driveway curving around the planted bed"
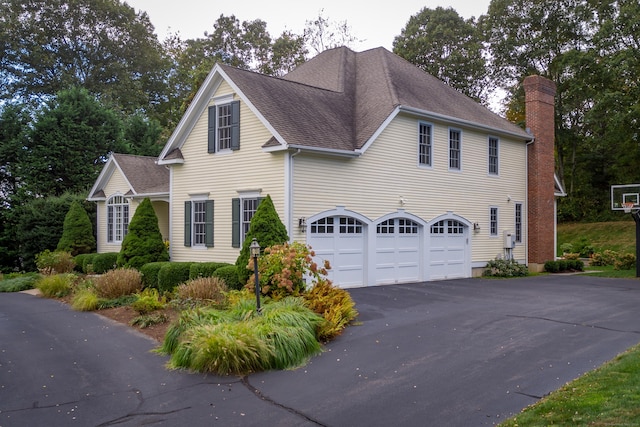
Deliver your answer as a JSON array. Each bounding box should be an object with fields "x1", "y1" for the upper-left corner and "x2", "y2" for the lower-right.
[{"x1": 0, "y1": 276, "x2": 640, "y2": 427}]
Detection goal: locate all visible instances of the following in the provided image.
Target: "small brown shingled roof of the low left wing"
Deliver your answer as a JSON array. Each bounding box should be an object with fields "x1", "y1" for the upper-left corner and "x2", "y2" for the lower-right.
[{"x1": 112, "y1": 153, "x2": 169, "y2": 194}]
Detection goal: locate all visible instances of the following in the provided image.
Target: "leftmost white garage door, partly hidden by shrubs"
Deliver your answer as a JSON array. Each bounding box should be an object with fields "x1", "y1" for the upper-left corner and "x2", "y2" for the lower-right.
[{"x1": 309, "y1": 216, "x2": 365, "y2": 287}]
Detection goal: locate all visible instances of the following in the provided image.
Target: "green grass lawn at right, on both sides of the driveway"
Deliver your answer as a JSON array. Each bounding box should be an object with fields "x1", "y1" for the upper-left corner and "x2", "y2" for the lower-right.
[{"x1": 500, "y1": 221, "x2": 640, "y2": 427}]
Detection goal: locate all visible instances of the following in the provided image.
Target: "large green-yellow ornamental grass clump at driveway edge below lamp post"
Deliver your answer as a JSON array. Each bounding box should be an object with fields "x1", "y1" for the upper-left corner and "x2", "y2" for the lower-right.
[{"x1": 161, "y1": 298, "x2": 322, "y2": 375}]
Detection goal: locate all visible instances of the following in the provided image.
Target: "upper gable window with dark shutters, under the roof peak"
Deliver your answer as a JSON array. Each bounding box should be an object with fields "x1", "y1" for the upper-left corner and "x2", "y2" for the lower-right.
[{"x1": 208, "y1": 101, "x2": 240, "y2": 153}]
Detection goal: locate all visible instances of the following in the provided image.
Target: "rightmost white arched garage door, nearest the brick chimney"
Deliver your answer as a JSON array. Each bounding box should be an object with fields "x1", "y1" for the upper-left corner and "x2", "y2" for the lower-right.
[{"x1": 428, "y1": 219, "x2": 469, "y2": 280}]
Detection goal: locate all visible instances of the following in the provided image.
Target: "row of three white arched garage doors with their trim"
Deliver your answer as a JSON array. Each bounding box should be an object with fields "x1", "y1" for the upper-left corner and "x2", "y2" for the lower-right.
[{"x1": 307, "y1": 209, "x2": 471, "y2": 287}]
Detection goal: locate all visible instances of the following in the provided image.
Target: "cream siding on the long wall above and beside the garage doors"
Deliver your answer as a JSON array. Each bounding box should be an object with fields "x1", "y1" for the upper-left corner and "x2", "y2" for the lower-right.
[{"x1": 293, "y1": 115, "x2": 526, "y2": 262}]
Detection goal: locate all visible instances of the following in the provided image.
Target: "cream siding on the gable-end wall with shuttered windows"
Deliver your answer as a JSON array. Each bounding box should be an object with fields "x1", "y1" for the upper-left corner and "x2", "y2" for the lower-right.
[{"x1": 170, "y1": 87, "x2": 285, "y2": 263}]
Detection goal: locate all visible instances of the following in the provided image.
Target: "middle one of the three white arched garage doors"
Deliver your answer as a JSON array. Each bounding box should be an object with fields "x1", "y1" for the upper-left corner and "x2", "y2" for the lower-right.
[{"x1": 375, "y1": 218, "x2": 421, "y2": 284}]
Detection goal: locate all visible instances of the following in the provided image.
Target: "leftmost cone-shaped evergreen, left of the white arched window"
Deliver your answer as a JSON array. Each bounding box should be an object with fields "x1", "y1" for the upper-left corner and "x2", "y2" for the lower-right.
[{"x1": 57, "y1": 200, "x2": 96, "y2": 256}]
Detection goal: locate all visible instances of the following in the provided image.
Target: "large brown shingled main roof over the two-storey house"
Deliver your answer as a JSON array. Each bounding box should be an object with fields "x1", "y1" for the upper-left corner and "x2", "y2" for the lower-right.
[{"x1": 221, "y1": 47, "x2": 528, "y2": 151}]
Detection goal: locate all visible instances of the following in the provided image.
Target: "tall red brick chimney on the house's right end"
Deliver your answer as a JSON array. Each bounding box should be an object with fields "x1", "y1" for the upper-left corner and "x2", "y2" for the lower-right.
[{"x1": 524, "y1": 76, "x2": 556, "y2": 271}]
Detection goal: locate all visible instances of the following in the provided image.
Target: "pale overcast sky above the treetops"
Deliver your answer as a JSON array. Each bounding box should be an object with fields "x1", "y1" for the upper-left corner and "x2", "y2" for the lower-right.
[{"x1": 126, "y1": 0, "x2": 490, "y2": 51}]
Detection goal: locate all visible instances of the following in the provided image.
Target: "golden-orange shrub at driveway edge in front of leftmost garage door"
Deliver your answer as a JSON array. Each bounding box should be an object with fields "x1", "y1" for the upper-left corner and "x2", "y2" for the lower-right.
[{"x1": 304, "y1": 280, "x2": 358, "y2": 341}]
